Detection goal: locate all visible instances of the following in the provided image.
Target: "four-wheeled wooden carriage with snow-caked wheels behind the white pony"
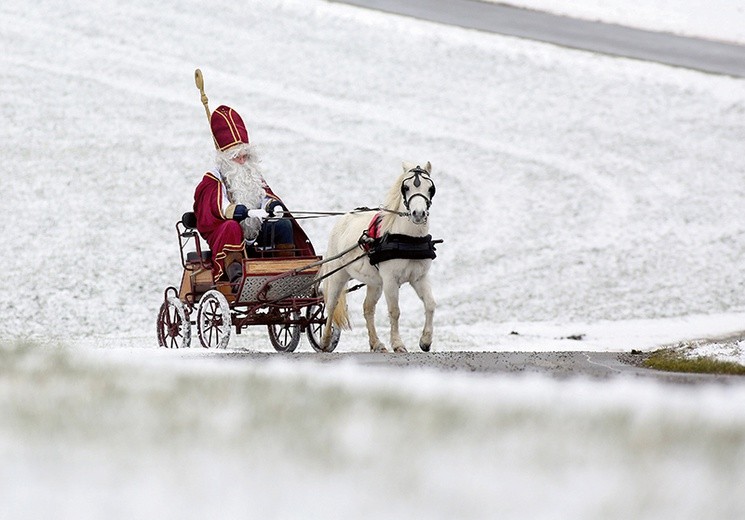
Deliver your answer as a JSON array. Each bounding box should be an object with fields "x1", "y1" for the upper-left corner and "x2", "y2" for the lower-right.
[{"x1": 157, "y1": 213, "x2": 339, "y2": 352}]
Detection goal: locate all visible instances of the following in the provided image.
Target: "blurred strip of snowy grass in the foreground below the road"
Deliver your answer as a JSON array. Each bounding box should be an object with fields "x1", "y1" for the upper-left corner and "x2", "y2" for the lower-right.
[{"x1": 0, "y1": 345, "x2": 745, "y2": 520}]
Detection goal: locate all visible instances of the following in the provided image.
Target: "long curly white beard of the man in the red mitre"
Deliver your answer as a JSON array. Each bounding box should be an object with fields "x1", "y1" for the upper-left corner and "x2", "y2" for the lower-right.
[{"x1": 217, "y1": 147, "x2": 265, "y2": 242}]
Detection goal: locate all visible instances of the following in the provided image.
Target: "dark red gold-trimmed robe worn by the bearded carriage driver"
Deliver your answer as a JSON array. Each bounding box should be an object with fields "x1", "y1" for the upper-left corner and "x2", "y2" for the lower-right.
[{"x1": 194, "y1": 172, "x2": 315, "y2": 281}]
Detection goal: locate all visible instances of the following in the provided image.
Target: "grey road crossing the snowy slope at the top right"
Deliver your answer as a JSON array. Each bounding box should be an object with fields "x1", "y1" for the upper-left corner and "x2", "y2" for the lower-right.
[{"x1": 329, "y1": 0, "x2": 745, "y2": 78}]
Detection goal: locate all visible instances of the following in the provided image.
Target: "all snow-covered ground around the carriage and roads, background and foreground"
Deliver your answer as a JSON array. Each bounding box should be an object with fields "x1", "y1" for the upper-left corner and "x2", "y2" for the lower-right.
[{"x1": 0, "y1": 0, "x2": 745, "y2": 518}]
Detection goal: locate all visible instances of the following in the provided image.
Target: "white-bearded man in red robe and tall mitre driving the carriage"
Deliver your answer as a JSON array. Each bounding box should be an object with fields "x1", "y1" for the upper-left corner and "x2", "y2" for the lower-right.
[{"x1": 194, "y1": 105, "x2": 315, "y2": 283}]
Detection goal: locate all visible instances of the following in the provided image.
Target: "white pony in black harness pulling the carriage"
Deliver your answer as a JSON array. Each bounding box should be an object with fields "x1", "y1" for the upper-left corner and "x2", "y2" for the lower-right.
[{"x1": 321, "y1": 162, "x2": 435, "y2": 352}]
